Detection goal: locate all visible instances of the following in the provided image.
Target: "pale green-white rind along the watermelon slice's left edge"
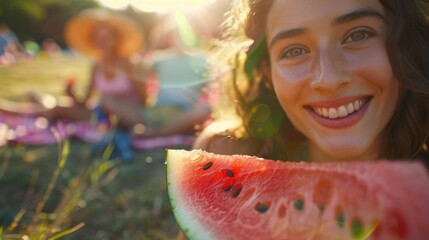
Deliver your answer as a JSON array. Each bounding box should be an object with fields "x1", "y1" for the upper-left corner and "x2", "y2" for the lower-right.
[{"x1": 167, "y1": 149, "x2": 216, "y2": 240}]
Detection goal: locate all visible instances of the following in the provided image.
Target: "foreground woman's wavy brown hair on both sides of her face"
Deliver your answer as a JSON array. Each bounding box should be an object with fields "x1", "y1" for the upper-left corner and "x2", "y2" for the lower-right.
[{"x1": 221, "y1": 0, "x2": 429, "y2": 160}]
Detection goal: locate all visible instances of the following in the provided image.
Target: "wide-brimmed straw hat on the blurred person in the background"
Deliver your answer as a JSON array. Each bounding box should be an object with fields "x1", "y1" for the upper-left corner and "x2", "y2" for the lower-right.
[{"x1": 64, "y1": 9, "x2": 143, "y2": 58}]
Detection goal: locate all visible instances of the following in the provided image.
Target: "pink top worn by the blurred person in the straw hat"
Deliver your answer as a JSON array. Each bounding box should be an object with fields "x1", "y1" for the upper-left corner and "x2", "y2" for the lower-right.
[{"x1": 94, "y1": 67, "x2": 139, "y2": 102}]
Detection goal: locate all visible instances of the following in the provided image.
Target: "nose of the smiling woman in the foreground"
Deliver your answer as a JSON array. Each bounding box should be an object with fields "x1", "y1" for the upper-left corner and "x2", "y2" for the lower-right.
[{"x1": 310, "y1": 49, "x2": 351, "y2": 92}]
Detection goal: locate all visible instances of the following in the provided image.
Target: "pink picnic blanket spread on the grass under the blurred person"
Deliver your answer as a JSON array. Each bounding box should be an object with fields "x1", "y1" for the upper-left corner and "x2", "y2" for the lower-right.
[{"x1": 0, "y1": 111, "x2": 195, "y2": 150}]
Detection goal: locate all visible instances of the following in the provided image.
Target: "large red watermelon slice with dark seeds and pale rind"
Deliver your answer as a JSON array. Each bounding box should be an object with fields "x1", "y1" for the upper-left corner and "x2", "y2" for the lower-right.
[{"x1": 167, "y1": 150, "x2": 429, "y2": 240}]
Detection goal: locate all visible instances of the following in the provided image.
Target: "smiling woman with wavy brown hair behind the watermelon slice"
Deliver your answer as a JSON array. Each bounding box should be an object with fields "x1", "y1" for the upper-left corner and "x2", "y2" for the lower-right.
[{"x1": 195, "y1": 0, "x2": 429, "y2": 162}]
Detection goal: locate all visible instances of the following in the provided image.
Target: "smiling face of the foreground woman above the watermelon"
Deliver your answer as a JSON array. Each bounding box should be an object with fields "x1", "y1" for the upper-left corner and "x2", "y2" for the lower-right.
[{"x1": 267, "y1": 0, "x2": 399, "y2": 161}]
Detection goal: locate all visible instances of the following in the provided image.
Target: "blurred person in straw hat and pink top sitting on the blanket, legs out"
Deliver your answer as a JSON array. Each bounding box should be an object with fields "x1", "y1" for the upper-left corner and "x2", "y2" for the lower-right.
[{"x1": 0, "y1": 9, "x2": 148, "y2": 160}]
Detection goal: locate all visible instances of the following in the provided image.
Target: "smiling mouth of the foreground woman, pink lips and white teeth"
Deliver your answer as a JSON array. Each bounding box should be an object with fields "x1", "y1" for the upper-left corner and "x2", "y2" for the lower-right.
[{"x1": 306, "y1": 97, "x2": 371, "y2": 128}]
